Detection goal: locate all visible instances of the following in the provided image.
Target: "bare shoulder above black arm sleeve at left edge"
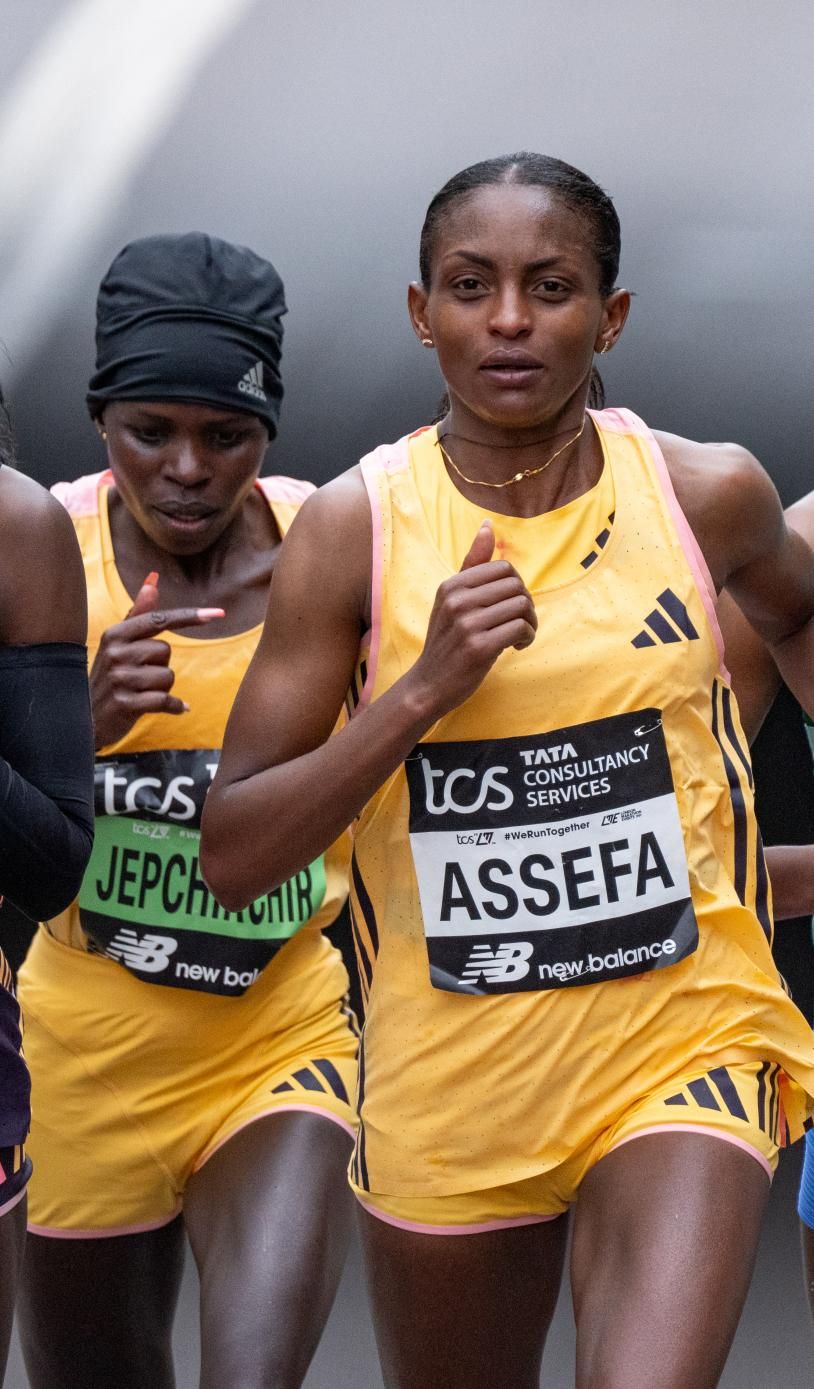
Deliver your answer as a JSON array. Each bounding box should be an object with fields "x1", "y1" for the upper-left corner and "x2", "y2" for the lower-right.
[{"x1": 0, "y1": 465, "x2": 88, "y2": 646}]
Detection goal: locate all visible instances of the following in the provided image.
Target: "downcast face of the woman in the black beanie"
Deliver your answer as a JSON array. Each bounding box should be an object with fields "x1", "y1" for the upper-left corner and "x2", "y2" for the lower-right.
[{"x1": 104, "y1": 400, "x2": 268, "y2": 554}]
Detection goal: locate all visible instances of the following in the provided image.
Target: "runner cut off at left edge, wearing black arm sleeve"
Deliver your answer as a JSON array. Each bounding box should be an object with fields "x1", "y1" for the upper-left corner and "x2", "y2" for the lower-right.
[{"x1": 0, "y1": 393, "x2": 93, "y2": 1383}]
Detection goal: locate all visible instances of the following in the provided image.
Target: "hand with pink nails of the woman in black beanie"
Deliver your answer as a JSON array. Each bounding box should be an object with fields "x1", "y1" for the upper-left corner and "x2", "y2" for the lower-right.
[{"x1": 90, "y1": 574, "x2": 225, "y2": 751}]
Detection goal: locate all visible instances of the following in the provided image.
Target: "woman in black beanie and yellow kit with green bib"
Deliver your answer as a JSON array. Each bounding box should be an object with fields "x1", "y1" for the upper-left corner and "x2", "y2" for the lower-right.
[{"x1": 21, "y1": 233, "x2": 357, "y2": 1389}]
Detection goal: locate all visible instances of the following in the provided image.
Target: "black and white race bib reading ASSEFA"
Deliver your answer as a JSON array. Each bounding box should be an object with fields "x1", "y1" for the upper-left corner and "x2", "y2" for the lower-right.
[{"x1": 404, "y1": 708, "x2": 699, "y2": 993}]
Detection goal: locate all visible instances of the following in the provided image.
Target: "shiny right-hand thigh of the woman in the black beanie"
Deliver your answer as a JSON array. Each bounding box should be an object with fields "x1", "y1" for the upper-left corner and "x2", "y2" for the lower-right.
[{"x1": 183, "y1": 1113, "x2": 353, "y2": 1389}]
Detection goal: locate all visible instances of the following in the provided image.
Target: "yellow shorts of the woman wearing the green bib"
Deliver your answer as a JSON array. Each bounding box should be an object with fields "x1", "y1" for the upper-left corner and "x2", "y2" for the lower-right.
[{"x1": 22, "y1": 931, "x2": 357, "y2": 1236}]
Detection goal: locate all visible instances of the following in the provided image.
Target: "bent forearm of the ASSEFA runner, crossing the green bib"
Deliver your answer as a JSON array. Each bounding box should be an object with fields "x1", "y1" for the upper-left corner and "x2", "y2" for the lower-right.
[{"x1": 200, "y1": 678, "x2": 436, "y2": 911}]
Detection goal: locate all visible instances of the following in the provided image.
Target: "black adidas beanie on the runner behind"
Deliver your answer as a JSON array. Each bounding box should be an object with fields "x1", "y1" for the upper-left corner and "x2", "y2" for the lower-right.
[{"x1": 86, "y1": 232, "x2": 286, "y2": 439}]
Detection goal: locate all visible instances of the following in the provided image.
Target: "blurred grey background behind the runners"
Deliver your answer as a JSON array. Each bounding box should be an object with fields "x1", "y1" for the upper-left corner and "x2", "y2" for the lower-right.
[{"x1": 0, "y1": 0, "x2": 814, "y2": 1389}]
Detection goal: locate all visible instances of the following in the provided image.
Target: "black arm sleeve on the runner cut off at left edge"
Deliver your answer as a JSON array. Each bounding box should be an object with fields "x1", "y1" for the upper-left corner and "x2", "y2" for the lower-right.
[{"x1": 0, "y1": 642, "x2": 93, "y2": 920}]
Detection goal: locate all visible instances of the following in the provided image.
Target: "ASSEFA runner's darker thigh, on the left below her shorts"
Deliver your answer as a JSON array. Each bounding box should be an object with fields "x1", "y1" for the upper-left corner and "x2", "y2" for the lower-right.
[{"x1": 360, "y1": 1208, "x2": 568, "y2": 1389}]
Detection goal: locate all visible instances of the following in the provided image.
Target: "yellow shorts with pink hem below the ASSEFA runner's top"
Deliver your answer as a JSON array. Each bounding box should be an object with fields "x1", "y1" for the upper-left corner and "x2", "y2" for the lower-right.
[{"x1": 351, "y1": 1063, "x2": 783, "y2": 1235}]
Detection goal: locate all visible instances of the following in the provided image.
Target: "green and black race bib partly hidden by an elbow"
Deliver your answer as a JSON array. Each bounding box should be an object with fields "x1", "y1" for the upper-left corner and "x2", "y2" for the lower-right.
[{"x1": 79, "y1": 749, "x2": 326, "y2": 995}]
